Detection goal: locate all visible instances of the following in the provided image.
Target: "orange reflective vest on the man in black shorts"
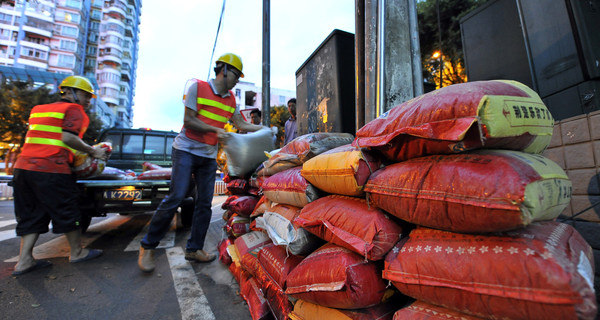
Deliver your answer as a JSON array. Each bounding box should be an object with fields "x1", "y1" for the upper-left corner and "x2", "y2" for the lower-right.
[{"x1": 21, "y1": 102, "x2": 90, "y2": 163}]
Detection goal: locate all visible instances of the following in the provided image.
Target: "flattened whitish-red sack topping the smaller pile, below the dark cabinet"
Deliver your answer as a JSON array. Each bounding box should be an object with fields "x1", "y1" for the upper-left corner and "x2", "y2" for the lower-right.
[{"x1": 258, "y1": 132, "x2": 354, "y2": 176}]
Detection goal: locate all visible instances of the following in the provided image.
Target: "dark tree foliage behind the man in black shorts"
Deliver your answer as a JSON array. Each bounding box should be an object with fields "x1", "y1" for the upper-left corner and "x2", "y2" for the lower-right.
[{"x1": 0, "y1": 79, "x2": 102, "y2": 145}]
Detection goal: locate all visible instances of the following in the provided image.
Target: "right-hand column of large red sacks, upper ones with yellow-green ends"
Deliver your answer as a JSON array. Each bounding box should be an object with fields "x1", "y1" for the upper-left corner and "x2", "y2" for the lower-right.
[{"x1": 353, "y1": 81, "x2": 597, "y2": 319}]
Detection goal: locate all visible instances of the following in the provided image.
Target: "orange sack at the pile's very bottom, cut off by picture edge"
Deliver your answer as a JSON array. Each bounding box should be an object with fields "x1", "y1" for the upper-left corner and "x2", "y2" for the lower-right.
[{"x1": 290, "y1": 300, "x2": 404, "y2": 320}]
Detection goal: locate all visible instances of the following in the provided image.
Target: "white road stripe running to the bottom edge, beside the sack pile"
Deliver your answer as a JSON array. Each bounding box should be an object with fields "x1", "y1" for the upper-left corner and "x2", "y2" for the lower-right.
[{"x1": 166, "y1": 247, "x2": 215, "y2": 320}]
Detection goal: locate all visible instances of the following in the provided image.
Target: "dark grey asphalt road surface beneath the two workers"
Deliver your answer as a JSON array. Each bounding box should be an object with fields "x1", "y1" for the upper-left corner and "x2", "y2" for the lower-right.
[{"x1": 0, "y1": 200, "x2": 250, "y2": 319}]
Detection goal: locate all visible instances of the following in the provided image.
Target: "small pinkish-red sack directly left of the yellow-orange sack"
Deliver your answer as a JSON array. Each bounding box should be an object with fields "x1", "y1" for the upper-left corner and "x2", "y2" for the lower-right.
[{"x1": 263, "y1": 167, "x2": 320, "y2": 207}]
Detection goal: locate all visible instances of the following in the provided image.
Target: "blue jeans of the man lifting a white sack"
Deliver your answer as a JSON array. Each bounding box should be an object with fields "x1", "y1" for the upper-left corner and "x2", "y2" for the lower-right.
[{"x1": 141, "y1": 149, "x2": 217, "y2": 251}]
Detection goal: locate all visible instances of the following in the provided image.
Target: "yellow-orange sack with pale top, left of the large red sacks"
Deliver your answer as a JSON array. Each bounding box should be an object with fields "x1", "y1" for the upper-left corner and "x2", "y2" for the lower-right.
[{"x1": 301, "y1": 144, "x2": 381, "y2": 196}]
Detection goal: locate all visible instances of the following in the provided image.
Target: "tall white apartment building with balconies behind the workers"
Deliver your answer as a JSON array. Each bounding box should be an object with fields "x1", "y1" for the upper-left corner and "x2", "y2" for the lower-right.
[{"x1": 0, "y1": 0, "x2": 142, "y2": 127}]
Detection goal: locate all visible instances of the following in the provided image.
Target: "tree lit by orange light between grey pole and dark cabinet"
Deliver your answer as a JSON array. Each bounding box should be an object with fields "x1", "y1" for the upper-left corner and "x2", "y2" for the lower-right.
[{"x1": 417, "y1": 0, "x2": 488, "y2": 88}]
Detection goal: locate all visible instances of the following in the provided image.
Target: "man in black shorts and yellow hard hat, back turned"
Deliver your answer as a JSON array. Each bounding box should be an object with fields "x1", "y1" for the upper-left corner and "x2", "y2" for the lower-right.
[{"x1": 13, "y1": 76, "x2": 107, "y2": 276}]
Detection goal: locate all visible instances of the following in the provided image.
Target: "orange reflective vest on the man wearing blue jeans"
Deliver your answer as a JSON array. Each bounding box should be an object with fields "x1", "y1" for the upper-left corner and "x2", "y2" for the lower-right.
[{"x1": 185, "y1": 80, "x2": 235, "y2": 146}]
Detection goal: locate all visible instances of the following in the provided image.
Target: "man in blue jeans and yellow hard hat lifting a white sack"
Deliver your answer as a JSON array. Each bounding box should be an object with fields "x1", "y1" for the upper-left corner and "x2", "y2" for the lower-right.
[{"x1": 138, "y1": 53, "x2": 264, "y2": 272}]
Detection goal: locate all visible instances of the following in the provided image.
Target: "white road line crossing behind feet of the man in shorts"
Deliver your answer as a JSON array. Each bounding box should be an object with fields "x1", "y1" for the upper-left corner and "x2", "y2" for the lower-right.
[{"x1": 4, "y1": 215, "x2": 131, "y2": 262}]
